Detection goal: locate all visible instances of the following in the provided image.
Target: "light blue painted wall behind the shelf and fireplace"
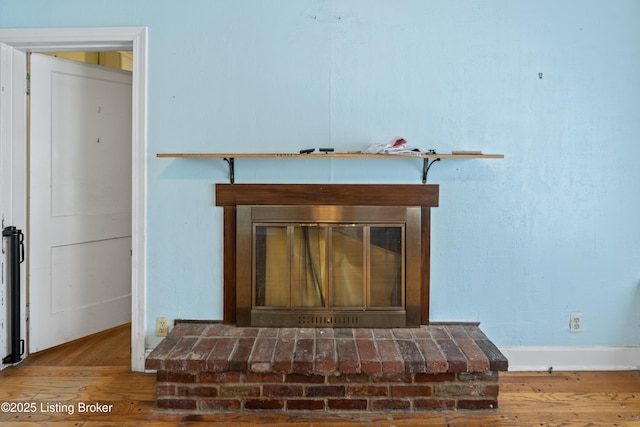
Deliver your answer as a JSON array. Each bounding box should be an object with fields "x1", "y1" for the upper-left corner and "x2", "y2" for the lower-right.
[{"x1": 0, "y1": 0, "x2": 640, "y2": 352}]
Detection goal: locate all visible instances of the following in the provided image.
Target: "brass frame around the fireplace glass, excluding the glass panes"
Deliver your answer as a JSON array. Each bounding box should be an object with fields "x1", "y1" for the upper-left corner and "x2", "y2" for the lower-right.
[{"x1": 236, "y1": 205, "x2": 422, "y2": 327}]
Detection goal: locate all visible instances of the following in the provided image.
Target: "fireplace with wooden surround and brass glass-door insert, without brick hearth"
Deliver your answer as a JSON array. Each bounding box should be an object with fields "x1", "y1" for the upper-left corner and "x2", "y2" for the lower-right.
[{"x1": 216, "y1": 184, "x2": 438, "y2": 328}]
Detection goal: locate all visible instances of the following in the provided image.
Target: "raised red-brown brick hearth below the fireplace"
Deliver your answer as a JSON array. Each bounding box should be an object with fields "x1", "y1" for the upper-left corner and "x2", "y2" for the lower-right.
[{"x1": 146, "y1": 323, "x2": 508, "y2": 413}]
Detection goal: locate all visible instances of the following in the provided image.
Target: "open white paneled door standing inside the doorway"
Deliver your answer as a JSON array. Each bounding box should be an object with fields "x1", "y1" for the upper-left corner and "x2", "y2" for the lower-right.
[{"x1": 28, "y1": 54, "x2": 132, "y2": 353}]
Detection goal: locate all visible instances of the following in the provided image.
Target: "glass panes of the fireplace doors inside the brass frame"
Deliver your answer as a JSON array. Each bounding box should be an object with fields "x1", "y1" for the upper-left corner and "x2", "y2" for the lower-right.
[{"x1": 253, "y1": 223, "x2": 405, "y2": 311}]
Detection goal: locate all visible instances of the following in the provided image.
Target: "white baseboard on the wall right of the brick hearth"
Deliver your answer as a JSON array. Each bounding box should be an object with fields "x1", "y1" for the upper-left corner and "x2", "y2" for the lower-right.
[{"x1": 500, "y1": 347, "x2": 640, "y2": 371}]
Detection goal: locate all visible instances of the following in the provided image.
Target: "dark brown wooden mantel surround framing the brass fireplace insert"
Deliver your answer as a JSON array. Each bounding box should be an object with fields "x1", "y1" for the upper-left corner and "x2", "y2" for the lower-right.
[{"x1": 216, "y1": 184, "x2": 439, "y2": 324}]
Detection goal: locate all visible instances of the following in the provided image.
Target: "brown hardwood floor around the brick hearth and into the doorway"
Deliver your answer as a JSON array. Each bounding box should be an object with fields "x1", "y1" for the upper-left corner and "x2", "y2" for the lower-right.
[{"x1": 0, "y1": 325, "x2": 640, "y2": 427}]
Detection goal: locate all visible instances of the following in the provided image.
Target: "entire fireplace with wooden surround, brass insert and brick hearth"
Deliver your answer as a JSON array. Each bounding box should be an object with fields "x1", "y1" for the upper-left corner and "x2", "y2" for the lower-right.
[{"x1": 150, "y1": 184, "x2": 508, "y2": 414}]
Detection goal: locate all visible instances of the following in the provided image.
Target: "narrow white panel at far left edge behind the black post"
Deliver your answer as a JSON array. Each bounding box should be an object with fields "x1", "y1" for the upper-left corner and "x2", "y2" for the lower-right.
[{"x1": 0, "y1": 43, "x2": 27, "y2": 370}]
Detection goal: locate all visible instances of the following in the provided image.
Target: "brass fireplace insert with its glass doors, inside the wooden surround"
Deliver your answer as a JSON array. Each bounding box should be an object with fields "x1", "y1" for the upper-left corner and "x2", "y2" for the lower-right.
[{"x1": 236, "y1": 205, "x2": 422, "y2": 327}]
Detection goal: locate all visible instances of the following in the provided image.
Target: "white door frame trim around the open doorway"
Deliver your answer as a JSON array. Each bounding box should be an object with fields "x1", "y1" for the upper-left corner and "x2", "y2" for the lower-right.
[{"x1": 0, "y1": 27, "x2": 147, "y2": 372}]
